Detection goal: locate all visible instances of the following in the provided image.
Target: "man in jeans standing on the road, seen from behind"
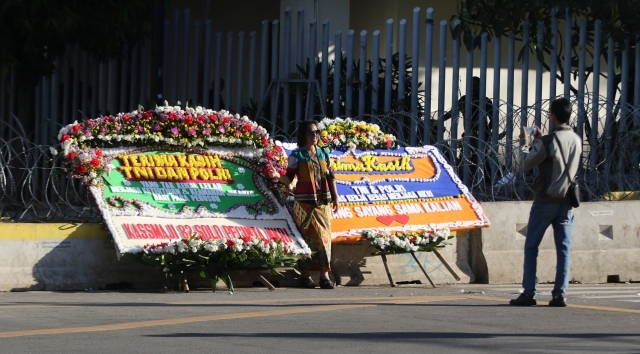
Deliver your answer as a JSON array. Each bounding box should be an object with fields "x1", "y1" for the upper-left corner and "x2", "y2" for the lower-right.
[{"x1": 510, "y1": 98, "x2": 582, "y2": 307}]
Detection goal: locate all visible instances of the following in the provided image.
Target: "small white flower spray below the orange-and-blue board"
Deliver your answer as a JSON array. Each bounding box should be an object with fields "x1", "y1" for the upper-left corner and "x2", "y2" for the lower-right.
[{"x1": 362, "y1": 228, "x2": 453, "y2": 253}]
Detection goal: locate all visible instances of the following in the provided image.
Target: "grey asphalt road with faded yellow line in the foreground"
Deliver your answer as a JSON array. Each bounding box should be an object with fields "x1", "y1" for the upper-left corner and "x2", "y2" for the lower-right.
[{"x1": 0, "y1": 284, "x2": 640, "y2": 353}]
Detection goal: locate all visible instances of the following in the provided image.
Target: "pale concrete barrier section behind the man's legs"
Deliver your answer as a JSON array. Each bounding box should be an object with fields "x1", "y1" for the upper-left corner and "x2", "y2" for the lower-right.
[{"x1": 476, "y1": 201, "x2": 640, "y2": 284}]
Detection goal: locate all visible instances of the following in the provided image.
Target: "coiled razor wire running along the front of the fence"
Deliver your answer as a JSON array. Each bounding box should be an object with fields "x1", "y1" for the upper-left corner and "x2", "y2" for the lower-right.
[{"x1": 0, "y1": 96, "x2": 640, "y2": 222}]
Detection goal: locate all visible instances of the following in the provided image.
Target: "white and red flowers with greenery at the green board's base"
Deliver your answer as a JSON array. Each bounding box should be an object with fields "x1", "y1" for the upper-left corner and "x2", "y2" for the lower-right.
[{"x1": 134, "y1": 235, "x2": 311, "y2": 292}]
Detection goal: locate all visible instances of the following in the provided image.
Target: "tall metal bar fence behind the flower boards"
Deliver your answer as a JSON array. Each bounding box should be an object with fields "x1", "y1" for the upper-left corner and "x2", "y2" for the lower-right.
[{"x1": 0, "y1": 8, "x2": 640, "y2": 221}]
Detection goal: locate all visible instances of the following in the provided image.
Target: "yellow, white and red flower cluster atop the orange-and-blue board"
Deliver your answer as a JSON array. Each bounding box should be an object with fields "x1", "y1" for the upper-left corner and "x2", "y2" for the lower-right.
[{"x1": 318, "y1": 118, "x2": 398, "y2": 150}]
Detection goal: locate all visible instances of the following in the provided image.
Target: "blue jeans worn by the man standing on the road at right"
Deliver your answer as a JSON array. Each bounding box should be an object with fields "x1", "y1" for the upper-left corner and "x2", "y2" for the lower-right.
[{"x1": 522, "y1": 201, "x2": 573, "y2": 296}]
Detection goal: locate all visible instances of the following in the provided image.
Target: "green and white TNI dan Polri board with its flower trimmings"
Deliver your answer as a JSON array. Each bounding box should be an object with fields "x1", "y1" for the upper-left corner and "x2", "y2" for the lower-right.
[{"x1": 53, "y1": 106, "x2": 310, "y2": 291}]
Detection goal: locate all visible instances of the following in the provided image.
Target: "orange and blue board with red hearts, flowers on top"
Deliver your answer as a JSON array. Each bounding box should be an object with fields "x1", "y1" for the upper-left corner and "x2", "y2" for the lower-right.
[{"x1": 283, "y1": 118, "x2": 490, "y2": 245}]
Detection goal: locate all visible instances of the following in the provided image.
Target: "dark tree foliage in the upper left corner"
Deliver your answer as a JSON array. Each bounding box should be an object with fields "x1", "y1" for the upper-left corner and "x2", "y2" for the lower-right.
[{"x1": 0, "y1": 0, "x2": 153, "y2": 78}]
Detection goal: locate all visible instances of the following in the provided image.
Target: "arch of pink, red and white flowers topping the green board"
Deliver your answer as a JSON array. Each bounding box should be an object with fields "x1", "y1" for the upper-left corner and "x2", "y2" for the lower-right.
[{"x1": 51, "y1": 105, "x2": 286, "y2": 185}]
